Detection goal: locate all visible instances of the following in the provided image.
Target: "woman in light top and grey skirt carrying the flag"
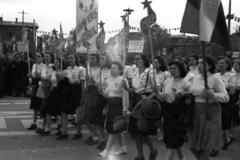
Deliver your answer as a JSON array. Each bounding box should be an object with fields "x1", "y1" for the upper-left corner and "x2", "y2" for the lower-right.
[{"x1": 187, "y1": 56, "x2": 229, "y2": 160}]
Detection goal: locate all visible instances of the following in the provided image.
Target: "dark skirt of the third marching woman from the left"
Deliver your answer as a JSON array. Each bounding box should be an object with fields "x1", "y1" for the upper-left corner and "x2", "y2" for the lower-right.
[{"x1": 46, "y1": 87, "x2": 62, "y2": 116}]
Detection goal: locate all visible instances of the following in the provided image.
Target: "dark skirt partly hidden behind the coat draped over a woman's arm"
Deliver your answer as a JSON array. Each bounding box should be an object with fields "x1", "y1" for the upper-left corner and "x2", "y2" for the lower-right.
[{"x1": 128, "y1": 93, "x2": 157, "y2": 136}]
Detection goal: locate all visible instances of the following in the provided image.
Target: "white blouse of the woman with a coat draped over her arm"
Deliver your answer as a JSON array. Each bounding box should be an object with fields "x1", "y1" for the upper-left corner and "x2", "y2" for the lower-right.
[{"x1": 132, "y1": 68, "x2": 160, "y2": 93}]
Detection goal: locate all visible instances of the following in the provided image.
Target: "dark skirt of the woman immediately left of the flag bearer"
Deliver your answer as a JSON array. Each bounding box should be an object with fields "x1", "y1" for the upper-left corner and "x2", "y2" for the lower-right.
[{"x1": 163, "y1": 103, "x2": 186, "y2": 149}]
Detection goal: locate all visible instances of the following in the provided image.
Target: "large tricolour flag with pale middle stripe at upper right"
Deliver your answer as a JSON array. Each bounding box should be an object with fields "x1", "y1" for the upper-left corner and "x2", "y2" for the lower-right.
[{"x1": 181, "y1": 0, "x2": 231, "y2": 51}]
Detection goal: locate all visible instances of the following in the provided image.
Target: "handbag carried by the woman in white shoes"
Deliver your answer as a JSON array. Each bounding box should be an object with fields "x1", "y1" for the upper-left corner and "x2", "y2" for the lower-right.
[{"x1": 113, "y1": 116, "x2": 129, "y2": 132}]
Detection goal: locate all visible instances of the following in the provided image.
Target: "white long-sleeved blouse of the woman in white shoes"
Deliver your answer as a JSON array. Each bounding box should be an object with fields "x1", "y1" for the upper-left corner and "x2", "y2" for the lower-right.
[{"x1": 105, "y1": 76, "x2": 129, "y2": 111}]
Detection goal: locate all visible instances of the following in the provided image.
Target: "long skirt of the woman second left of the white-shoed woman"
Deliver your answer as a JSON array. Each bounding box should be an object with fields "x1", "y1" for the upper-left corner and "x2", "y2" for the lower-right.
[{"x1": 80, "y1": 86, "x2": 99, "y2": 122}]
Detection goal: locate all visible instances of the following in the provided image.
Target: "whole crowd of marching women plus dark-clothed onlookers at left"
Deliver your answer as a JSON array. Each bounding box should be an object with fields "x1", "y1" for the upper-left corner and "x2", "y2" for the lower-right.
[{"x1": 2, "y1": 52, "x2": 240, "y2": 160}]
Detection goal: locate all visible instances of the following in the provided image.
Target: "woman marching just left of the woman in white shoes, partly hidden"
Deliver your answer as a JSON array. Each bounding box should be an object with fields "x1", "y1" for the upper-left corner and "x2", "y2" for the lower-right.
[{"x1": 90, "y1": 54, "x2": 112, "y2": 150}]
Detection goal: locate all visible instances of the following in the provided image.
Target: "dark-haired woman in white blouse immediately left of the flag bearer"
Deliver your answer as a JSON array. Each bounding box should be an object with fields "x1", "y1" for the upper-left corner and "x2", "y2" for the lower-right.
[{"x1": 157, "y1": 60, "x2": 190, "y2": 160}]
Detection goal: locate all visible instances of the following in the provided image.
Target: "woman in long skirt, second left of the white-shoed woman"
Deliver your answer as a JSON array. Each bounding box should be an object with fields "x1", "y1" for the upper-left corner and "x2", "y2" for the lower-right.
[{"x1": 81, "y1": 54, "x2": 100, "y2": 145}]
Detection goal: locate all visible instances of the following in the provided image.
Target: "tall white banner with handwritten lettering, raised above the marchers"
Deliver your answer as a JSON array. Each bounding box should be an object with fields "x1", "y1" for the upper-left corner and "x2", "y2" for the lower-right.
[{"x1": 76, "y1": 0, "x2": 98, "y2": 53}]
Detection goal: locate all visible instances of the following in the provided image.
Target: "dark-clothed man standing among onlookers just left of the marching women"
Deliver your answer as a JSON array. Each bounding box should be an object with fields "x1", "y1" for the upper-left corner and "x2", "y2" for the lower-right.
[{"x1": 12, "y1": 54, "x2": 28, "y2": 97}]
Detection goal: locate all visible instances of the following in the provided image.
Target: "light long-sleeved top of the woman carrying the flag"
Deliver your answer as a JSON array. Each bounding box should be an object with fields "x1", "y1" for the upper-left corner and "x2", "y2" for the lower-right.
[{"x1": 189, "y1": 73, "x2": 229, "y2": 103}]
